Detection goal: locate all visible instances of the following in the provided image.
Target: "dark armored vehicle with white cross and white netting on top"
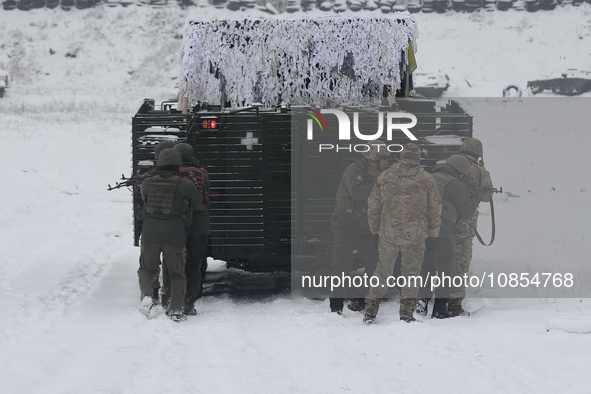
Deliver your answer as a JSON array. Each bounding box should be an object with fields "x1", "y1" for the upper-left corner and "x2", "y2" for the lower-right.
[{"x1": 127, "y1": 13, "x2": 472, "y2": 272}]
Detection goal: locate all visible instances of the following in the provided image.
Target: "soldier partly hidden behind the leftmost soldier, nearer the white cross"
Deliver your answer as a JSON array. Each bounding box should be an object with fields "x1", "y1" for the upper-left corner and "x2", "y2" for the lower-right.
[{"x1": 162, "y1": 142, "x2": 210, "y2": 315}]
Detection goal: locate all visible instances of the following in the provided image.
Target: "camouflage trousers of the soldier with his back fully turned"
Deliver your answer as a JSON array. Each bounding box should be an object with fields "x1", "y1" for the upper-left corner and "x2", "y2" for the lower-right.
[{"x1": 365, "y1": 238, "x2": 425, "y2": 318}]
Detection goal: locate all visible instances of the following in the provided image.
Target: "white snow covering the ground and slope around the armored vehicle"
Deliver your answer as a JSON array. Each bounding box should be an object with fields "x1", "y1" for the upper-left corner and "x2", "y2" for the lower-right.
[{"x1": 0, "y1": 4, "x2": 591, "y2": 394}]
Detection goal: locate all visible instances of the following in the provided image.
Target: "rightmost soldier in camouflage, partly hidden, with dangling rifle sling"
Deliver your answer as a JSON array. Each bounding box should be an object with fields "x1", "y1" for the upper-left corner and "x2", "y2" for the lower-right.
[{"x1": 448, "y1": 138, "x2": 493, "y2": 316}]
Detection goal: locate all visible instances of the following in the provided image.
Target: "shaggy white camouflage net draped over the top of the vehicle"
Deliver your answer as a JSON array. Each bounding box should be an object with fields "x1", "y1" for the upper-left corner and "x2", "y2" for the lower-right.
[{"x1": 180, "y1": 12, "x2": 418, "y2": 106}]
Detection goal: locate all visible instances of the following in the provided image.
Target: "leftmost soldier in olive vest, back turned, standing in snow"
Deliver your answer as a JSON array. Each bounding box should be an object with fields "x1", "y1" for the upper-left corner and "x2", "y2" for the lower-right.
[{"x1": 138, "y1": 148, "x2": 203, "y2": 322}]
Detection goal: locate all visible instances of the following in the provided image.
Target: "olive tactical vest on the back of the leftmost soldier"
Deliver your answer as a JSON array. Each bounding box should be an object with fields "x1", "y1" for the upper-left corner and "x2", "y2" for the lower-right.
[{"x1": 145, "y1": 175, "x2": 192, "y2": 223}]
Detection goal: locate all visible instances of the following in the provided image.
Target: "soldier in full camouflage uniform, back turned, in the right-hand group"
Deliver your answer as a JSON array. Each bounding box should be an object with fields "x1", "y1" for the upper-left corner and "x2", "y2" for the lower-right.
[{"x1": 363, "y1": 143, "x2": 441, "y2": 324}]
